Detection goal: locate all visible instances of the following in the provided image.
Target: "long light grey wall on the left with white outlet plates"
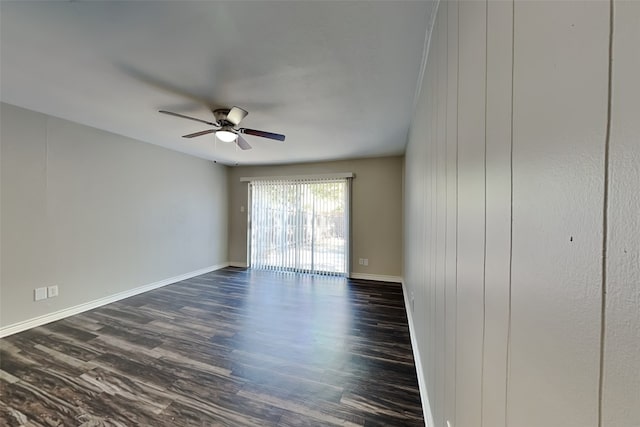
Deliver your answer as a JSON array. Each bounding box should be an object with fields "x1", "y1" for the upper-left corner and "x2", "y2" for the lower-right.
[{"x1": 0, "y1": 104, "x2": 227, "y2": 327}]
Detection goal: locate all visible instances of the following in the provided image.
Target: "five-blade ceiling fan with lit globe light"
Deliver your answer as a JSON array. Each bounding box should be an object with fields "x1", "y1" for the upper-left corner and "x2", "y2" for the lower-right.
[{"x1": 159, "y1": 107, "x2": 284, "y2": 150}]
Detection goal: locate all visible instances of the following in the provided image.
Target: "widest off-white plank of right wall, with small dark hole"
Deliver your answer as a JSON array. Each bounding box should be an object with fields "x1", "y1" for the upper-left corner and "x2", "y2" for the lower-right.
[{"x1": 507, "y1": 0, "x2": 609, "y2": 427}]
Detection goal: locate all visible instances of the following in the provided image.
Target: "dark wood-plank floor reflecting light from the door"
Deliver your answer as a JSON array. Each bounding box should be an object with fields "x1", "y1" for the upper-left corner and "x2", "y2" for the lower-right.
[{"x1": 0, "y1": 268, "x2": 424, "y2": 427}]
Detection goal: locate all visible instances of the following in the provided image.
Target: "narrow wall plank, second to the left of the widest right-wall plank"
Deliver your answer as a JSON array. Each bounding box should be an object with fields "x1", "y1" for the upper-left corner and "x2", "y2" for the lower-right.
[{"x1": 456, "y1": 1, "x2": 486, "y2": 427}]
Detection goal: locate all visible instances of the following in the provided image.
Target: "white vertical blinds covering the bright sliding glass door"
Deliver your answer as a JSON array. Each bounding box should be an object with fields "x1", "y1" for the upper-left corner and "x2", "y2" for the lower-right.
[{"x1": 250, "y1": 178, "x2": 349, "y2": 275}]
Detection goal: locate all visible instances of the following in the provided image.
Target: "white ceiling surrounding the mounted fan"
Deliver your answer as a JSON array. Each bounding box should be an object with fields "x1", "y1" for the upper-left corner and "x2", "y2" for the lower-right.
[{"x1": 0, "y1": 0, "x2": 434, "y2": 164}]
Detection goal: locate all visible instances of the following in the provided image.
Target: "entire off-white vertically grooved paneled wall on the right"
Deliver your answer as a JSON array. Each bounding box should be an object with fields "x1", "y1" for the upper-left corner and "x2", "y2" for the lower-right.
[{"x1": 404, "y1": 0, "x2": 640, "y2": 427}]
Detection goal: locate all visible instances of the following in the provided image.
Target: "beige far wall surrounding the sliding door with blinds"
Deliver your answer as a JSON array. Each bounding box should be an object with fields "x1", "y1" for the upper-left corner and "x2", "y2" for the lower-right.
[{"x1": 229, "y1": 157, "x2": 402, "y2": 277}]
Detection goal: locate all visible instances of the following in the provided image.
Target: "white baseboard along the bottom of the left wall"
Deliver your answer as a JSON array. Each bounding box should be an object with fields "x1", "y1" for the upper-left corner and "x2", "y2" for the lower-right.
[{"x1": 0, "y1": 263, "x2": 229, "y2": 338}]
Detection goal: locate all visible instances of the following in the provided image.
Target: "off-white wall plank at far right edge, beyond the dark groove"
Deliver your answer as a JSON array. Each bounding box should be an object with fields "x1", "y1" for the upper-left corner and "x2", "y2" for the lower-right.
[{"x1": 602, "y1": 1, "x2": 640, "y2": 427}]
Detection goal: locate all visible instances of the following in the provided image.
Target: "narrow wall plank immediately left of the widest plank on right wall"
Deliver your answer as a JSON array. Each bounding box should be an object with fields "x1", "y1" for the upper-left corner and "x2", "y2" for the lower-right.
[{"x1": 482, "y1": 1, "x2": 513, "y2": 427}]
